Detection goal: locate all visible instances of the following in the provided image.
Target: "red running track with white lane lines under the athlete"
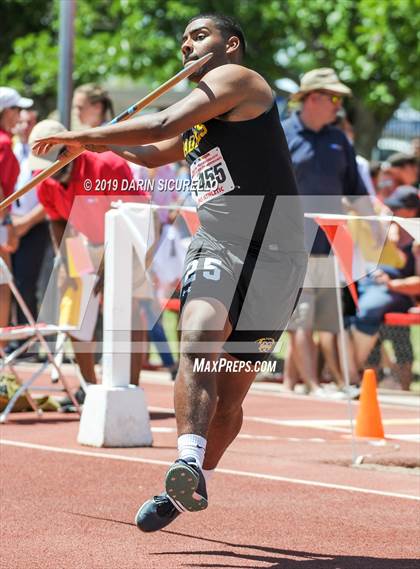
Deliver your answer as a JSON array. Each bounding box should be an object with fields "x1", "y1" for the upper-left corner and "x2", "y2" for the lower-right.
[{"x1": 0, "y1": 372, "x2": 420, "y2": 569}]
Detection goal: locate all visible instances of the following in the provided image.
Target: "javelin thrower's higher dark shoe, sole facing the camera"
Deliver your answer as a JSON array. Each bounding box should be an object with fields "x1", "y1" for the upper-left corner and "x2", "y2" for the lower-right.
[{"x1": 165, "y1": 458, "x2": 208, "y2": 512}]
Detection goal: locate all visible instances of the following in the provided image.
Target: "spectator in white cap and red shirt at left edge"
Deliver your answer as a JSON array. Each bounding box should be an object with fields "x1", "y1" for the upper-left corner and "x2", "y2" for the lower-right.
[{"x1": 0, "y1": 87, "x2": 33, "y2": 338}]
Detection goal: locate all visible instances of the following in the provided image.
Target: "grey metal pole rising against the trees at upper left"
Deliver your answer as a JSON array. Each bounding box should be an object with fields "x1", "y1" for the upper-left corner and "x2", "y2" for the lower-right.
[{"x1": 58, "y1": 0, "x2": 76, "y2": 128}]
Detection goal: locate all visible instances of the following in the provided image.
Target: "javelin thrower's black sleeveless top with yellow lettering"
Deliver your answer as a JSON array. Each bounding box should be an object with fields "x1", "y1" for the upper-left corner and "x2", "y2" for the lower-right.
[{"x1": 183, "y1": 103, "x2": 304, "y2": 251}]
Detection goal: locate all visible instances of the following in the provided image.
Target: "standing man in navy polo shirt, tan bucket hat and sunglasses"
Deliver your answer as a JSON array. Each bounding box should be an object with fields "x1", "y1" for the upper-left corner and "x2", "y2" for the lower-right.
[{"x1": 283, "y1": 68, "x2": 371, "y2": 395}]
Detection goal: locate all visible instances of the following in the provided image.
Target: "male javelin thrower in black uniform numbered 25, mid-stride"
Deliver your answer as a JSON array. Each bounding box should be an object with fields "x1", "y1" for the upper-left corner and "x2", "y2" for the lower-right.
[{"x1": 34, "y1": 14, "x2": 307, "y2": 532}]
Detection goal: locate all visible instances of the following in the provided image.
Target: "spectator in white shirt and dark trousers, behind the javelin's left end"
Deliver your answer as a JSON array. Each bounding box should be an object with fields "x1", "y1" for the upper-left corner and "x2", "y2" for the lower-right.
[{"x1": 12, "y1": 110, "x2": 50, "y2": 324}]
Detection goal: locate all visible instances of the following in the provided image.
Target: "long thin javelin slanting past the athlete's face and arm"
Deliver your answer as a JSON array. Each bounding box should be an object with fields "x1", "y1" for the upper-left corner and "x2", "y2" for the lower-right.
[{"x1": 0, "y1": 53, "x2": 213, "y2": 211}]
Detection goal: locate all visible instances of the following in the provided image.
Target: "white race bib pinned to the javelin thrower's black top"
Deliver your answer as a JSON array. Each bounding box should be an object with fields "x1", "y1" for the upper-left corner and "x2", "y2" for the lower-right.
[{"x1": 191, "y1": 146, "x2": 235, "y2": 207}]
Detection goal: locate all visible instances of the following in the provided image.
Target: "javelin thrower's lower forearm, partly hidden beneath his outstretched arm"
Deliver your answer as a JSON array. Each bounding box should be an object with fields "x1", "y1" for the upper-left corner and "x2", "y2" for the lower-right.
[{"x1": 108, "y1": 136, "x2": 184, "y2": 168}]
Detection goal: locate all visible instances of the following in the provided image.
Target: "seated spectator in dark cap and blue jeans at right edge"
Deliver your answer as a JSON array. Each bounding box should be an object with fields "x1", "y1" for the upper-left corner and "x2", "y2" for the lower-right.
[{"x1": 351, "y1": 186, "x2": 420, "y2": 389}]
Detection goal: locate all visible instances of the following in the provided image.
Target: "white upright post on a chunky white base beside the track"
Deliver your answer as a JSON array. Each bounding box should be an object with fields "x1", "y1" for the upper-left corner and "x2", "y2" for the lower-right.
[{"x1": 77, "y1": 203, "x2": 153, "y2": 447}]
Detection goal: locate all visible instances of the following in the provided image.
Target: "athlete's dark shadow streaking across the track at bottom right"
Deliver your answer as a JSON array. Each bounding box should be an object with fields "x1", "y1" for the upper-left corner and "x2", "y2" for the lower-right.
[{"x1": 156, "y1": 530, "x2": 419, "y2": 569}]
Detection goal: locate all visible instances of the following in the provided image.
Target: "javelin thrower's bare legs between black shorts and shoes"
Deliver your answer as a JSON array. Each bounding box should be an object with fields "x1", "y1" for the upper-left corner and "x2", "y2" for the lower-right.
[{"x1": 175, "y1": 299, "x2": 256, "y2": 470}]
